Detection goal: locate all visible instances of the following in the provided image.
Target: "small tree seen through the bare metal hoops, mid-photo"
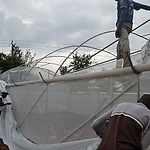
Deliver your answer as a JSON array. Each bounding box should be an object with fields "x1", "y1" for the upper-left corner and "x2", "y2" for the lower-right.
[{"x1": 59, "y1": 52, "x2": 92, "y2": 75}]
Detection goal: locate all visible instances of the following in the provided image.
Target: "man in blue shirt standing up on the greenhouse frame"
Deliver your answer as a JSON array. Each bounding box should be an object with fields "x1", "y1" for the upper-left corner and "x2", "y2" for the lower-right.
[{"x1": 115, "y1": 0, "x2": 150, "y2": 68}]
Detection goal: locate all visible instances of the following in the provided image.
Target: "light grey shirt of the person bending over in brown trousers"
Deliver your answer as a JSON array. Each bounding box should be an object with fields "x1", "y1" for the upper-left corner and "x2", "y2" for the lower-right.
[{"x1": 92, "y1": 102, "x2": 150, "y2": 150}]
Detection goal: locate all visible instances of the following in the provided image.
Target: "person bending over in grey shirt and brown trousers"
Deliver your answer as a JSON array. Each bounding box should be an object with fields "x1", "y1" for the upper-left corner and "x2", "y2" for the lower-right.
[{"x1": 92, "y1": 94, "x2": 150, "y2": 150}]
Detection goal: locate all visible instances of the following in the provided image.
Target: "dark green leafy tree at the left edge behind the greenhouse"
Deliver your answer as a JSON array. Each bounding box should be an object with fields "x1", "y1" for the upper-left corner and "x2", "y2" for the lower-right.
[{"x1": 0, "y1": 41, "x2": 35, "y2": 73}]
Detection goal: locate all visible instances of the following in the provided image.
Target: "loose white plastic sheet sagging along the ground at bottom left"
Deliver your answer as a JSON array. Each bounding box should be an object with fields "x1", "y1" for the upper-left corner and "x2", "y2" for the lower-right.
[{"x1": 0, "y1": 81, "x2": 100, "y2": 150}]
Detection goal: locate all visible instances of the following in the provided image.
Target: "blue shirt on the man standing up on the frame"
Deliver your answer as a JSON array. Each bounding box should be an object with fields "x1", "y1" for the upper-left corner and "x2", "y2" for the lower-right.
[{"x1": 117, "y1": 0, "x2": 140, "y2": 24}]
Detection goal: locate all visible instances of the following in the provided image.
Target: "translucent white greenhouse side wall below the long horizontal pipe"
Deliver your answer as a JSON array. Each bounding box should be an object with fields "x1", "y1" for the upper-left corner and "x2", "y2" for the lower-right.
[{"x1": 4, "y1": 69, "x2": 150, "y2": 150}]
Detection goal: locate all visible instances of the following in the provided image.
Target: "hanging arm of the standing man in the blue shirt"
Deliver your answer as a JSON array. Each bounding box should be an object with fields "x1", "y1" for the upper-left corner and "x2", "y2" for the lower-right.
[{"x1": 115, "y1": 8, "x2": 127, "y2": 38}]
